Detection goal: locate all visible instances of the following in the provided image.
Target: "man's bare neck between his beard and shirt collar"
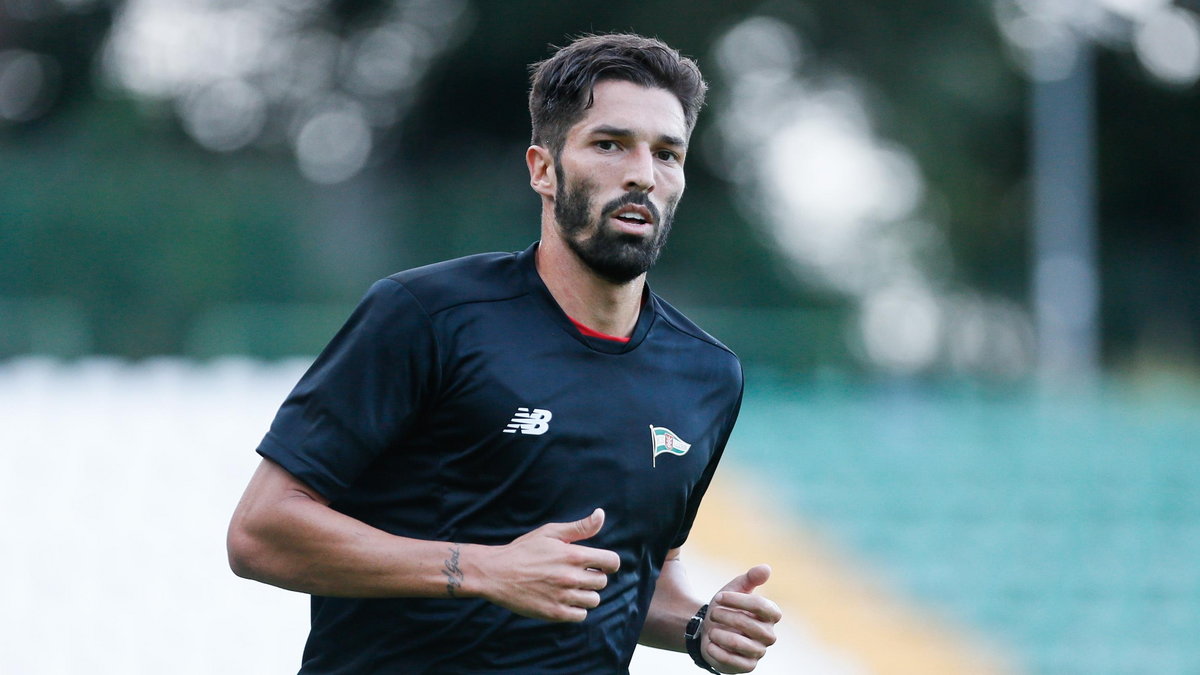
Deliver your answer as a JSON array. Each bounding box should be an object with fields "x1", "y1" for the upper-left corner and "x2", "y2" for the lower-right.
[{"x1": 536, "y1": 223, "x2": 646, "y2": 338}]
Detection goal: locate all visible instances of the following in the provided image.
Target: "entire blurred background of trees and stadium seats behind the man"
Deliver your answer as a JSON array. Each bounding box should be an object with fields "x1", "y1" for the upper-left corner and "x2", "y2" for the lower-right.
[{"x1": 0, "y1": 0, "x2": 1200, "y2": 674}]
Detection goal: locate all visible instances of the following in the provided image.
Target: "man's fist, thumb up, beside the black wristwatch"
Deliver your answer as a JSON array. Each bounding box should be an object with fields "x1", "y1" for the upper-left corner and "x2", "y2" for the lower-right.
[{"x1": 700, "y1": 565, "x2": 784, "y2": 673}]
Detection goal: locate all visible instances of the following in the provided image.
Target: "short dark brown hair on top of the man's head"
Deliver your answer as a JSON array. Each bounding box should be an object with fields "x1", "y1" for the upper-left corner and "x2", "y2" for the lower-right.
[{"x1": 529, "y1": 34, "x2": 708, "y2": 157}]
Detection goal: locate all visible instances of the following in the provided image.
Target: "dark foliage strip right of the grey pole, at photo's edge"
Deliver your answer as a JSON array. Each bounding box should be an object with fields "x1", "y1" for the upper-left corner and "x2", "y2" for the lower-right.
[{"x1": 1098, "y1": 48, "x2": 1200, "y2": 362}]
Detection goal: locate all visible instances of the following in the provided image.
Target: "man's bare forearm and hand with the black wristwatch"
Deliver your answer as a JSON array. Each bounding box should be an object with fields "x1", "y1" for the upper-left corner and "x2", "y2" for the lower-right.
[{"x1": 638, "y1": 549, "x2": 782, "y2": 673}]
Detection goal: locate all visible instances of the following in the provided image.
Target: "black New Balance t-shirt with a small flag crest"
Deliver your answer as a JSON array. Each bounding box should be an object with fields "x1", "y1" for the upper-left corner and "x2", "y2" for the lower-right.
[{"x1": 258, "y1": 244, "x2": 742, "y2": 675}]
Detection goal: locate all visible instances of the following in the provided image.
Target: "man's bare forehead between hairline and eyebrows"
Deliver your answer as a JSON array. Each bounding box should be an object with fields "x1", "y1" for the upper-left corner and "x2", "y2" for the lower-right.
[{"x1": 570, "y1": 79, "x2": 688, "y2": 138}]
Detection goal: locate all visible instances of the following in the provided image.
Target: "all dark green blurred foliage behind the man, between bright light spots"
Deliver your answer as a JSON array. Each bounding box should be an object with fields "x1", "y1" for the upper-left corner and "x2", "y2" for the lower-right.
[{"x1": 0, "y1": 0, "x2": 1200, "y2": 369}]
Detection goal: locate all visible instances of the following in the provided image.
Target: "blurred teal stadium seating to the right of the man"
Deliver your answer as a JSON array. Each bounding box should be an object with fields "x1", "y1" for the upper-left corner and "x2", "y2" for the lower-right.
[{"x1": 732, "y1": 374, "x2": 1200, "y2": 675}]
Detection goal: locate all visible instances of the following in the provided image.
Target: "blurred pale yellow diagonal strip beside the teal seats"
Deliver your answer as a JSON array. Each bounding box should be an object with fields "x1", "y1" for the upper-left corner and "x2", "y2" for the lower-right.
[{"x1": 688, "y1": 467, "x2": 1016, "y2": 675}]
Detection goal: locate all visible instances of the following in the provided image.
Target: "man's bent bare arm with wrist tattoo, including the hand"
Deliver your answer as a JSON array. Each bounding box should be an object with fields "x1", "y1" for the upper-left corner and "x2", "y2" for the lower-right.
[{"x1": 227, "y1": 459, "x2": 619, "y2": 621}]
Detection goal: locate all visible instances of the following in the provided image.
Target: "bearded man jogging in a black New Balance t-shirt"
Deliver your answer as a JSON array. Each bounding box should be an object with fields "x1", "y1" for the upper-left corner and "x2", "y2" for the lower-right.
[{"x1": 228, "y1": 35, "x2": 780, "y2": 675}]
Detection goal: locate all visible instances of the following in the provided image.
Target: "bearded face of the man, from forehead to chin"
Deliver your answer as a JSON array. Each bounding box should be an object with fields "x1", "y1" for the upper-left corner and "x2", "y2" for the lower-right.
[{"x1": 554, "y1": 80, "x2": 686, "y2": 283}]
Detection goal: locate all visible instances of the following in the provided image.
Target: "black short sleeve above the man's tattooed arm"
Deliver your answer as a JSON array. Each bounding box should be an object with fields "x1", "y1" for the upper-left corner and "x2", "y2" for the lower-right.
[{"x1": 258, "y1": 279, "x2": 439, "y2": 501}]
